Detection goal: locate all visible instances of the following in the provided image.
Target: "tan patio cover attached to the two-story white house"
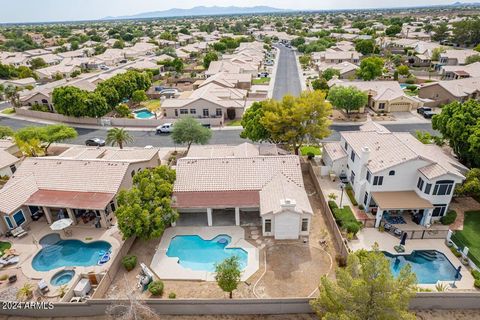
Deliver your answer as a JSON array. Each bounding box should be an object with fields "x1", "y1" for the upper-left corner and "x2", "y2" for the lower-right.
[{"x1": 372, "y1": 191, "x2": 433, "y2": 210}]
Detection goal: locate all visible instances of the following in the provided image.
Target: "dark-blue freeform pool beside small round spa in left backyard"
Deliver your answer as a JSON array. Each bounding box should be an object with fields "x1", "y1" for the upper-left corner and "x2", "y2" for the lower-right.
[{"x1": 32, "y1": 233, "x2": 112, "y2": 271}]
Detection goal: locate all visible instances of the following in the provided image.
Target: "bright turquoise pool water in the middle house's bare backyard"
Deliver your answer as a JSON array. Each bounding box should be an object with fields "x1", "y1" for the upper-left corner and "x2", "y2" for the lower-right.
[{"x1": 167, "y1": 235, "x2": 248, "y2": 272}]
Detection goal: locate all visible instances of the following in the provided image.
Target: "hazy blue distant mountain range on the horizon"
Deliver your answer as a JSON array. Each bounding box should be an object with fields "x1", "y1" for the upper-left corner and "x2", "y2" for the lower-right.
[{"x1": 105, "y1": 6, "x2": 291, "y2": 20}]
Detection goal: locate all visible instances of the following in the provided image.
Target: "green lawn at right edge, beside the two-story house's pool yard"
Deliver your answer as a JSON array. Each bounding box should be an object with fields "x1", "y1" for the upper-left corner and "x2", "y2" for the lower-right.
[{"x1": 452, "y1": 211, "x2": 480, "y2": 265}]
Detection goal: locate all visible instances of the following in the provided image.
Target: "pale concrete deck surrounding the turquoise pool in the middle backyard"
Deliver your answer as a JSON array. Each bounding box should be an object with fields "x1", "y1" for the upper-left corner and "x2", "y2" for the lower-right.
[{"x1": 150, "y1": 226, "x2": 260, "y2": 281}]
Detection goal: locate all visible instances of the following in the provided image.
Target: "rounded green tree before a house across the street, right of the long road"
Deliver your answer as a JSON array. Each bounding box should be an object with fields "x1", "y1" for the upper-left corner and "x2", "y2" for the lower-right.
[{"x1": 328, "y1": 86, "x2": 368, "y2": 116}]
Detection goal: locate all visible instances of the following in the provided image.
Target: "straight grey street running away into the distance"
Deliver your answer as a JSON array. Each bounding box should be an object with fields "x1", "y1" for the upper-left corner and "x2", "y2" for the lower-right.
[{"x1": 272, "y1": 45, "x2": 302, "y2": 100}]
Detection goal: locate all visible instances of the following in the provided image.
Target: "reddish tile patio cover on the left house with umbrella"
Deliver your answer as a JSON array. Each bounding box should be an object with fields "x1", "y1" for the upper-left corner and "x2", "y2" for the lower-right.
[{"x1": 25, "y1": 189, "x2": 115, "y2": 210}]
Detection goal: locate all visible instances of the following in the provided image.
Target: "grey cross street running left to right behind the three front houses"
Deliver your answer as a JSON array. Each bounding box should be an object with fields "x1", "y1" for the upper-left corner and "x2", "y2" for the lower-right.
[{"x1": 0, "y1": 117, "x2": 436, "y2": 147}]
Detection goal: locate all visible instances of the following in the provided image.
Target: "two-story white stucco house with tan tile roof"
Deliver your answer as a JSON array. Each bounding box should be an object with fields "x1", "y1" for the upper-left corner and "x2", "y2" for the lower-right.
[{"x1": 322, "y1": 122, "x2": 467, "y2": 227}]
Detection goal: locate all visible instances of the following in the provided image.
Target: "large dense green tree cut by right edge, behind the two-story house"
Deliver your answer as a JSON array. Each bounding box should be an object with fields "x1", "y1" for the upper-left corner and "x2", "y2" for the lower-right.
[{"x1": 432, "y1": 100, "x2": 480, "y2": 167}]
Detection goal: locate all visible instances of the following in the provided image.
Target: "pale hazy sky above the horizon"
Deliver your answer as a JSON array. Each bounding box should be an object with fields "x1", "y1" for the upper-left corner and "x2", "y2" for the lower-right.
[{"x1": 0, "y1": 0, "x2": 456, "y2": 23}]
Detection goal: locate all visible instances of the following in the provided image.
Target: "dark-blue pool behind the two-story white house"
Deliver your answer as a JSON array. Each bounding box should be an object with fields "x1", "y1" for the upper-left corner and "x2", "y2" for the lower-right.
[{"x1": 383, "y1": 250, "x2": 461, "y2": 284}]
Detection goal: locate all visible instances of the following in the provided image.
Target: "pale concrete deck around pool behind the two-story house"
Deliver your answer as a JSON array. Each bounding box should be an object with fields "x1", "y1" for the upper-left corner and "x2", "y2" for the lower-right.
[{"x1": 348, "y1": 228, "x2": 474, "y2": 291}]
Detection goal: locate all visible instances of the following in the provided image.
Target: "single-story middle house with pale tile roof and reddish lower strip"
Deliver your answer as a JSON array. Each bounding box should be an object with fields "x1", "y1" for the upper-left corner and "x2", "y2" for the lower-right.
[{"x1": 172, "y1": 144, "x2": 313, "y2": 239}]
